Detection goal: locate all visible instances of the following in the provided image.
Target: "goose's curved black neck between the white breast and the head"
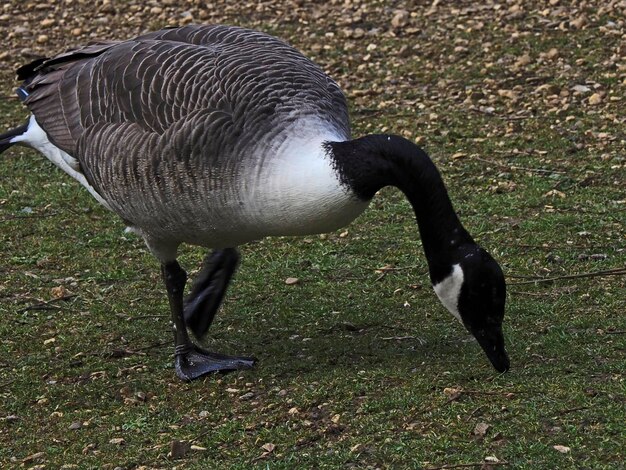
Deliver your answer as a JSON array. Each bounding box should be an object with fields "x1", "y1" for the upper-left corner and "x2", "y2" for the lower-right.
[{"x1": 327, "y1": 135, "x2": 473, "y2": 282}]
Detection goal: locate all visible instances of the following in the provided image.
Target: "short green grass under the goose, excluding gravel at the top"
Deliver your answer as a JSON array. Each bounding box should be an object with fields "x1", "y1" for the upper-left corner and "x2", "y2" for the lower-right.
[{"x1": 0, "y1": 2, "x2": 626, "y2": 469}]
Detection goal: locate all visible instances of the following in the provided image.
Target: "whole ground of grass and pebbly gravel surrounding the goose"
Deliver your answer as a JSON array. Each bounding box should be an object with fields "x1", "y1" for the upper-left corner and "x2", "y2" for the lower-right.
[{"x1": 0, "y1": 0, "x2": 626, "y2": 469}]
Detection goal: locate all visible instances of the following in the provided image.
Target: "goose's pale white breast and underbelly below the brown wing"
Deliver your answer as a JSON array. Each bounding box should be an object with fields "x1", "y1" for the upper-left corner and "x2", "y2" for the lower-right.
[{"x1": 132, "y1": 121, "x2": 369, "y2": 257}]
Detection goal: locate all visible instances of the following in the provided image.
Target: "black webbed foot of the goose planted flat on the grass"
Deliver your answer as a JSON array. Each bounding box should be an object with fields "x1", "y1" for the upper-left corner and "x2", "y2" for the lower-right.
[{"x1": 174, "y1": 345, "x2": 256, "y2": 382}]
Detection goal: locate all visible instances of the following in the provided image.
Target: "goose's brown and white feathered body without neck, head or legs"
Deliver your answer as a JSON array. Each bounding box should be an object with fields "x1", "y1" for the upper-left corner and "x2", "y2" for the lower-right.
[{"x1": 12, "y1": 26, "x2": 365, "y2": 261}]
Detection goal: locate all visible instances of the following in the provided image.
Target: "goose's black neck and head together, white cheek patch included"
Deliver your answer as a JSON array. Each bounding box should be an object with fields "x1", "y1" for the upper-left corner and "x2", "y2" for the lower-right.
[{"x1": 327, "y1": 135, "x2": 509, "y2": 372}]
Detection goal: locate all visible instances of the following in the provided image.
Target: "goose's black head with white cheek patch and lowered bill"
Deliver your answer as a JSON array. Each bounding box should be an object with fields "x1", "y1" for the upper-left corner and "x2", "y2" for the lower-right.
[{"x1": 431, "y1": 243, "x2": 509, "y2": 372}]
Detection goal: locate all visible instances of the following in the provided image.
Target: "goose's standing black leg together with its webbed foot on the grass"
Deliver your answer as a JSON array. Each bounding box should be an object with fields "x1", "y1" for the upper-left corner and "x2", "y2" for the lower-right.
[{"x1": 161, "y1": 261, "x2": 254, "y2": 381}]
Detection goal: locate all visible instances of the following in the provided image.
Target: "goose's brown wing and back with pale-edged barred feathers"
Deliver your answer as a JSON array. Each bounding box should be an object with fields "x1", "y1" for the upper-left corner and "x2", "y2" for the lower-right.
[{"x1": 21, "y1": 26, "x2": 349, "y2": 206}]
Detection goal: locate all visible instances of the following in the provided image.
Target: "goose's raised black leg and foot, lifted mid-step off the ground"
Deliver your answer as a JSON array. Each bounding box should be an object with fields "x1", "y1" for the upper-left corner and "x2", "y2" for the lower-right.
[{"x1": 185, "y1": 248, "x2": 239, "y2": 338}]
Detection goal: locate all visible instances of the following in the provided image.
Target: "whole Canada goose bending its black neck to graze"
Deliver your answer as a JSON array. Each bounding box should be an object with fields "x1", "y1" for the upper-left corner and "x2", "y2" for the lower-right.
[{"x1": 0, "y1": 25, "x2": 509, "y2": 381}]
